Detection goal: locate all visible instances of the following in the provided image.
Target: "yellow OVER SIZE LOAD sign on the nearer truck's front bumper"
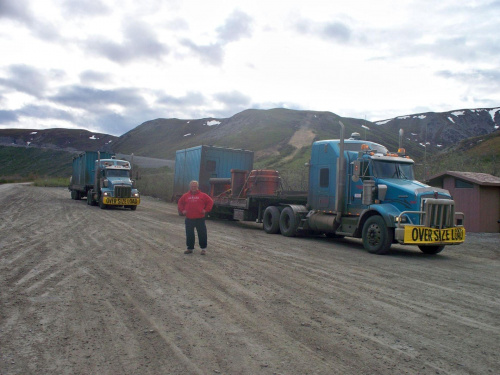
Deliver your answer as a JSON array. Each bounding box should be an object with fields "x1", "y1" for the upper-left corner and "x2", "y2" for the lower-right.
[{"x1": 404, "y1": 225, "x2": 465, "y2": 245}]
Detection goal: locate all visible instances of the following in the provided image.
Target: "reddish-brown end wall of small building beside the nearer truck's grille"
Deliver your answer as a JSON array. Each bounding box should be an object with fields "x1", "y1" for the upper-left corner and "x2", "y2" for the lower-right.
[{"x1": 443, "y1": 176, "x2": 482, "y2": 232}]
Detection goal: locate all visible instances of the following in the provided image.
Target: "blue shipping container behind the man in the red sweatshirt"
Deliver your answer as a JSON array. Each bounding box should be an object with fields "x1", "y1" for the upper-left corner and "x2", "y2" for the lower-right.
[{"x1": 173, "y1": 146, "x2": 253, "y2": 199}]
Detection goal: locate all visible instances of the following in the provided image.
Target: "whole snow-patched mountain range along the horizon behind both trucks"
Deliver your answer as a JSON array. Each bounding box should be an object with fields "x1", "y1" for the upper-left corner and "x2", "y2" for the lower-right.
[{"x1": 0, "y1": 108, "x2": 500, "y2": 182}]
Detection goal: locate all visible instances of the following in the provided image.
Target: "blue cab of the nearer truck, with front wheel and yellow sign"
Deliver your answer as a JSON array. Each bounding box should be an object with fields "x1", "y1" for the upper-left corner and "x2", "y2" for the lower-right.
[{"x1": 307, "y1": 140, "x2": 465, "y2": 254}]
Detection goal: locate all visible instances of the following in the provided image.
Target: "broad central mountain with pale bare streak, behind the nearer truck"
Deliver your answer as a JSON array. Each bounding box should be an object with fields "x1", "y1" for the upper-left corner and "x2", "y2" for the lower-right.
[{"x1": 109, "y1": 108, "x2": 420, "y2": 159}]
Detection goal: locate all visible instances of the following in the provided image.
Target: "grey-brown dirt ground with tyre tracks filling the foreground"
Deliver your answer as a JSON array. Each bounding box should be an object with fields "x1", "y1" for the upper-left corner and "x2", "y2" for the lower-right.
[{"x1": 0, "y1": 184, "x2": 500, "y2": 375}]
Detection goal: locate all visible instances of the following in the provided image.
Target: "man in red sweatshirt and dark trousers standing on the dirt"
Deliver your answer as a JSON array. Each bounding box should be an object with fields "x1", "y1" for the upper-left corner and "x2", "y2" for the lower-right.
[{"x1": 177, "y1": 181, "x2": 214, "y2": 255}]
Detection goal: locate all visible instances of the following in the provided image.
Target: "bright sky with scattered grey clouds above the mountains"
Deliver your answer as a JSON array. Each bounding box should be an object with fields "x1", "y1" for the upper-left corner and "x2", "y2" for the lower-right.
[{"x1": 0, "y1": 0, "x2": 500, "y2": 136}]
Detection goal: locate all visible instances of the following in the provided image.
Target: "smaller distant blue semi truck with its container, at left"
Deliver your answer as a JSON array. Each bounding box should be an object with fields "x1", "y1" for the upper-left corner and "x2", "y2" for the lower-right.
[{"x1": 68, "y1": 151, "x2": 141, "y2": 210}]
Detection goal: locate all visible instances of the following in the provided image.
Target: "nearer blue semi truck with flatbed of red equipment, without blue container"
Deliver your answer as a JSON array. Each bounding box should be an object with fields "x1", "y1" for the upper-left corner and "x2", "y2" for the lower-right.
[{"x1": 176, "y1": 124, "x2": 465, "y2": 254}]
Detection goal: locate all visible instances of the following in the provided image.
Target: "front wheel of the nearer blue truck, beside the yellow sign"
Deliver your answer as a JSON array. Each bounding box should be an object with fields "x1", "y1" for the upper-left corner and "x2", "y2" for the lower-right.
[{"x1": 363, "y1": 215, "x2": 394, "y2": 255}]
